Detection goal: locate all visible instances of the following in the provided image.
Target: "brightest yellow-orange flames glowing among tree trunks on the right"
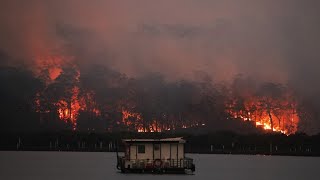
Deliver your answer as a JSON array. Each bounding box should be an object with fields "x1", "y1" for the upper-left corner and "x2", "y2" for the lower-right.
[{"x1": 227, "y1": 97, "x2": 299, "y2": 135}]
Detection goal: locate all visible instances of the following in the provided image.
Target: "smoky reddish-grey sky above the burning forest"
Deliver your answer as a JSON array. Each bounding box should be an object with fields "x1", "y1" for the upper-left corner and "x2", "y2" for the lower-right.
[{"x1": 0, "y1": 0, "x2": 320, "y2": 87}]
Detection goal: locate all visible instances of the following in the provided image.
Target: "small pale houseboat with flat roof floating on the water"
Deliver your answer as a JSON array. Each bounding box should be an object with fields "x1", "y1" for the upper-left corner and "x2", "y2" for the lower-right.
[{"x1": 117, "y1": 137, "x2": 195, "y2": 174}]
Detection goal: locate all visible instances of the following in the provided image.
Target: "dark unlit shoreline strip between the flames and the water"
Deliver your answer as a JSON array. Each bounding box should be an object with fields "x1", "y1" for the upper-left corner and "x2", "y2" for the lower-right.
[{"x1": 0, "y1": 131, "x2": 320, "y2": 156}]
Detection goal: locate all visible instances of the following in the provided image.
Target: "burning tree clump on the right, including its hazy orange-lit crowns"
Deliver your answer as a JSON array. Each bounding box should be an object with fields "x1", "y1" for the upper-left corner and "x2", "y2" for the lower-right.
[{"x1": 226, "y1": 80, "x2": 300, "y2": 135}]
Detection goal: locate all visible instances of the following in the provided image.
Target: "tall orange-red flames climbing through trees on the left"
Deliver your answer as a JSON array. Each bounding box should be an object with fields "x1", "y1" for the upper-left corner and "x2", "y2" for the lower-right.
[{"x1": 35, "y1": 56, "x2": 101, "y2": 130}]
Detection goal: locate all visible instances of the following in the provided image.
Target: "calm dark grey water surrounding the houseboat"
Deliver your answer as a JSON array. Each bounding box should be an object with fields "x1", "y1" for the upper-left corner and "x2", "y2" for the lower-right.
[{"x1": 0, "y1": 152, "x2": 320, "y2": 180}]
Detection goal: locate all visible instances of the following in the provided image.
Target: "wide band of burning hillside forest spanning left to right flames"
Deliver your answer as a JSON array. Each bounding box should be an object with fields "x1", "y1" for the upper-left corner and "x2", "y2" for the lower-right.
[{"x1": 1, "y1": 54, "x2": 306, "y2": 135}]
